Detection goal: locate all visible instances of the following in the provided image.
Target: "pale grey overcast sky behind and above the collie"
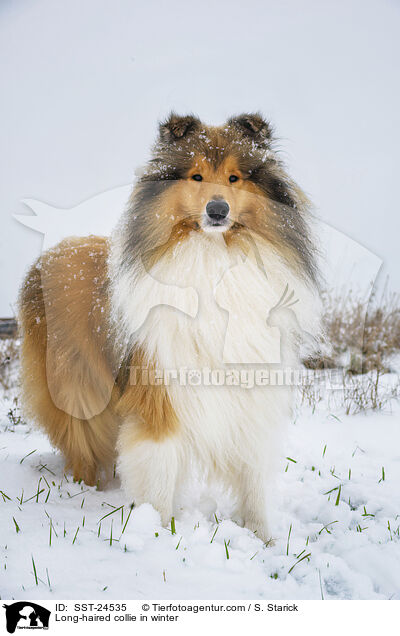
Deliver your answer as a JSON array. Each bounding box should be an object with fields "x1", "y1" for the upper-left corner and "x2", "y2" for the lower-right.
[{"x1": 0, "y1": 0, "x2": 400, "y2": 316}]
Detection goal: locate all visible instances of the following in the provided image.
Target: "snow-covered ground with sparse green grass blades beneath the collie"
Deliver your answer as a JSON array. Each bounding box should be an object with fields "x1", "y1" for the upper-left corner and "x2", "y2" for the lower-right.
[{"x1": 0, "y1": 348, "x2": 400, "y2": 599}]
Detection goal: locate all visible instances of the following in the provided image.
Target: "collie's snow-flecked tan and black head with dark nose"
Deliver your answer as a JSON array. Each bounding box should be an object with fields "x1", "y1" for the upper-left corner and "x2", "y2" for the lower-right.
[{"x1": 126, "y1": 113, "x2": 315, "y2": 278}]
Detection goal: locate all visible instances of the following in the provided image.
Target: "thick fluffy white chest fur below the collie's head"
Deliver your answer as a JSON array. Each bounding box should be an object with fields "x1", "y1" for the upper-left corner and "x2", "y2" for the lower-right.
[{"x1": 109, "y1": 233, "x2": 312, "y2": 463}]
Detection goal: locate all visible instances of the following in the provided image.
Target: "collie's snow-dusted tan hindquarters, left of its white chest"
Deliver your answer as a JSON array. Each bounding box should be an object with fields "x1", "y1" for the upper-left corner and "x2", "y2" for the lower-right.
[{"x1": 19, "y1": 237, "x2": 118, "y2": 485}]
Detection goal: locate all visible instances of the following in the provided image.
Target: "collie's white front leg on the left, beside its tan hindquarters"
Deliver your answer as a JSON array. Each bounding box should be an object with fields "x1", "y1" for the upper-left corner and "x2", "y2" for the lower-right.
[{"x1": 117, "y1": 417, "x2": 179, "y2": 526}]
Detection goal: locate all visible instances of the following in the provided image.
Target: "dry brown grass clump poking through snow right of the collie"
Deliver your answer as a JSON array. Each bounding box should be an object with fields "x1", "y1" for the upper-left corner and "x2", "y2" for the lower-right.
[{"x1": 301, "y1": 289, "x2": 400, "y2": 415}]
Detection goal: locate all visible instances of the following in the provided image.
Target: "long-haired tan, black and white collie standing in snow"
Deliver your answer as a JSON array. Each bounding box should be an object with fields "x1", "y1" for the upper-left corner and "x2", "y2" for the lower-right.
[{"x1": 19, "y1": 114, "x2": 318, "y2": 541}]
